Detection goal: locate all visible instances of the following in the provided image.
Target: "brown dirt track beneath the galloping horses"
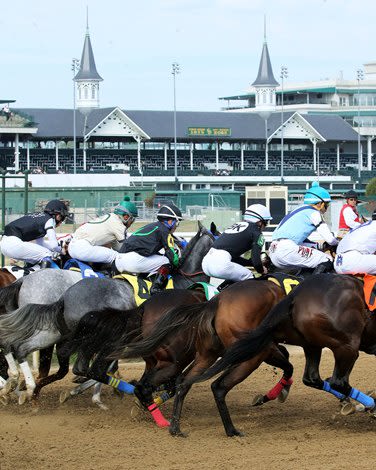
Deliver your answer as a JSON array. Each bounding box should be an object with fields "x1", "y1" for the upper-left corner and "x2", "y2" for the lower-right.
[{"x1": 0, "y1": 352, "x2": 376, "y2": 470}]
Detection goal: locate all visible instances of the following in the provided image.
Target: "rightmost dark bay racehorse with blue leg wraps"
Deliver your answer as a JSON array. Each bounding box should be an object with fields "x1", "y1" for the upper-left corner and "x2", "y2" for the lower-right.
[{"x1": 191, "y1": 274, "x2": 376, "y2": 417}]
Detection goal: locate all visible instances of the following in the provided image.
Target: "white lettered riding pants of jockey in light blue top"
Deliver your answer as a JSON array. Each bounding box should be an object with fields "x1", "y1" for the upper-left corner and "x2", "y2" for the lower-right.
[{"x1": 269, "y1": 239, "x2": 333, "y2": 268}]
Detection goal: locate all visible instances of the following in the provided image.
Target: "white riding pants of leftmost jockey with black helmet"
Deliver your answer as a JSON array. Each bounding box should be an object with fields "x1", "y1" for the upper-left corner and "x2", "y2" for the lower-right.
[{"x1": 0, "y1": 235, "x2": 52, "y2": 264}]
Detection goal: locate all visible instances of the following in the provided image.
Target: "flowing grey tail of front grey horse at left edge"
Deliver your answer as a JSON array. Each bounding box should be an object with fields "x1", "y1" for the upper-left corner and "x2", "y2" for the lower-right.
[{"x1": 0, "y1": 298, "x2": 67, "y2": 346}]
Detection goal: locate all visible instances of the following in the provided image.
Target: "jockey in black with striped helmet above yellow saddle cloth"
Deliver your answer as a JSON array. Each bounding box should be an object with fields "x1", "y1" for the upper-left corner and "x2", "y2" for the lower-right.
[{"x1": 115, "y1": 203, "x2": 182, "y2": 294}]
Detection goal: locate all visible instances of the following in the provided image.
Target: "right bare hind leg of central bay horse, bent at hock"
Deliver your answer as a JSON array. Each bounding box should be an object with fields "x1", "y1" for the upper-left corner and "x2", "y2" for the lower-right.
[{"x1": 211, "y1": 349, "x2": 269, "y2": 437}]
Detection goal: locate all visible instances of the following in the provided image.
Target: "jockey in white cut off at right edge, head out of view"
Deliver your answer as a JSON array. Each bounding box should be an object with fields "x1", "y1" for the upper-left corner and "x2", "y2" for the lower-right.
[{"x1": 334, "y1": 211, "x2": 376, "y2": 274}]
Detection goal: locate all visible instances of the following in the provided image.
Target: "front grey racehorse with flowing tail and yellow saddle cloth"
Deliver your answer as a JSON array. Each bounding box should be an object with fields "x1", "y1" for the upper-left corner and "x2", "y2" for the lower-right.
[{"x1": 0, "y1": 223, "x2": 215, "y2": 400}]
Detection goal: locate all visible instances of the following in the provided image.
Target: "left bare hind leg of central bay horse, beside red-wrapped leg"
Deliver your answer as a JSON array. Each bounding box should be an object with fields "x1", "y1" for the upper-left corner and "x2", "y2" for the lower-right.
[{"x1": 169, "y1": 351, "x2": 218, "y2": 437}]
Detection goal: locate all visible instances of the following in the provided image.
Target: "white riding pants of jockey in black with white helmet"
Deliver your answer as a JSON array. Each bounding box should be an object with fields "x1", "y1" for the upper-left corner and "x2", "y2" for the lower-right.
[{"x1": 202, "y1": 248, "x2": 254, "y2": 282}]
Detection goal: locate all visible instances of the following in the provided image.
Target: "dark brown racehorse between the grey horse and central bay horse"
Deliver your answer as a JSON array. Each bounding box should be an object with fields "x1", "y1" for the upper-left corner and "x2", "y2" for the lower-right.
[{"x1": 57, "y1": 289, "x2": 206, "y2": 420}]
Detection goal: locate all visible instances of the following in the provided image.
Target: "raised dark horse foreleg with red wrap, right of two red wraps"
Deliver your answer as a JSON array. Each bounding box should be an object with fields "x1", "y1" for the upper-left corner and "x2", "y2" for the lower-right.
[{"x1": 252, "y1": 346, "x2": 294, "y2": 406}]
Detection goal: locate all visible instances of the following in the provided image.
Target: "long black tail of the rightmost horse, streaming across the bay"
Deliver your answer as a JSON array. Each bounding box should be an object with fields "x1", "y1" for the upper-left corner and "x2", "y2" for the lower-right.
[{"x1": 188, "y1": 292, "x2": 294, "y2": 384}]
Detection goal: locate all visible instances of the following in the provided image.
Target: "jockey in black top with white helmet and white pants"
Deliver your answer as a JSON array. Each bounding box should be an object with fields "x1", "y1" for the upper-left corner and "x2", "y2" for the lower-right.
[{"x1": 202, "y1": 204, "x2": 272, "y2": 282}]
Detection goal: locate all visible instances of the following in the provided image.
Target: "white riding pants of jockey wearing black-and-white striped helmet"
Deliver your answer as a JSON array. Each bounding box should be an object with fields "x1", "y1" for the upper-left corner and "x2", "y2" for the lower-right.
[{"x1": 115, "y1": 251, "x2": 170, "y2": 274}]
